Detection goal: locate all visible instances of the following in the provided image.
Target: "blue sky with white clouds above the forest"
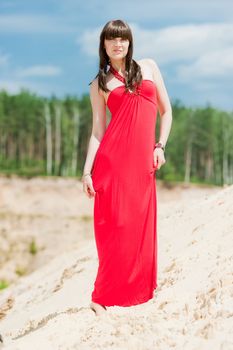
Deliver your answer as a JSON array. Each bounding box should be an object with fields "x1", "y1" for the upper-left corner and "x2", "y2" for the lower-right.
[{"x1": 0, "y1": 0, "x2": 233, "y2": 110}]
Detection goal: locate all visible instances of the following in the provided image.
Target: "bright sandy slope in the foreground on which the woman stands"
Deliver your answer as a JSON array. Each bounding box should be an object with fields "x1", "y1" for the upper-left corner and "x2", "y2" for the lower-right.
[{"x1": 0, "y1": 179, "x2": 233, "y2": 350}]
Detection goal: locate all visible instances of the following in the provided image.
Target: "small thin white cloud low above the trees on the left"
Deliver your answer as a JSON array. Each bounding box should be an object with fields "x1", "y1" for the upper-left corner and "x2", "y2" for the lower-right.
[{"x1": 16, "y1": 66, "x2": 61, "y2": 77}]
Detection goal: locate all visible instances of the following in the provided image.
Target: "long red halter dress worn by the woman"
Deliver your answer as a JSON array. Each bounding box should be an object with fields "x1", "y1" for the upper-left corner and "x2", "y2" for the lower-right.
[{"x1": 92, "y1": 67, "x2": 157, "y2": 306}]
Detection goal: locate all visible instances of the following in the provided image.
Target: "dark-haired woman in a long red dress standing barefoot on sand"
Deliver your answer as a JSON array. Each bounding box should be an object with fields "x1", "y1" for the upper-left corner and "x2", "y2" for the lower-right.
[{"x1": 82, "y1": 20, "x2": 172, "y2": 315}]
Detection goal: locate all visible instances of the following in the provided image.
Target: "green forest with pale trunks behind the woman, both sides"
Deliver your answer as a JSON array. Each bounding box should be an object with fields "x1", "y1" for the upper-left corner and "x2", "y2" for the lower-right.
[{"x1": 0, "y1": 89, "x2": 233, "y2": 186}]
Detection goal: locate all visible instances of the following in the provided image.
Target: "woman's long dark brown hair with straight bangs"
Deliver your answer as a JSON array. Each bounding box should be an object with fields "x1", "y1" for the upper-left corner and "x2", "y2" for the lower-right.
[{"x1": 89, "y1": 19, "x2": 142, "y2": 92}]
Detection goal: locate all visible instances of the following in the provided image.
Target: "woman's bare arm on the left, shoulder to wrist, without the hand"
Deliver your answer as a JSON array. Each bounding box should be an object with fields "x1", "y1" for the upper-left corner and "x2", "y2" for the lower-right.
[{"x1": 83, "y1": 78, "x2": 106, "y2": 176}]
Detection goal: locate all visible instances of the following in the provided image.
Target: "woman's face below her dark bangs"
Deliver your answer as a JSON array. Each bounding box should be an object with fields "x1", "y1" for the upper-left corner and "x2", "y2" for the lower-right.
[{"x1": 104, "y1": 37, "x2": 129, "y2": 60}]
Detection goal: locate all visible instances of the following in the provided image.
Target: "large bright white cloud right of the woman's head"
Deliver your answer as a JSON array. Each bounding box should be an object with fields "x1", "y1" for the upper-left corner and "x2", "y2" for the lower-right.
[{"x1": 134, "y1": 23, "x2": 233, "y2": 64}]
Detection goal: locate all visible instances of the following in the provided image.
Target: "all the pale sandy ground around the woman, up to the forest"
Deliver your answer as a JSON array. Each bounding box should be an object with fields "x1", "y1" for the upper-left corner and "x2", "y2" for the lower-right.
[{"x1": 0, "y1": 178, "x2": 233, "y2": 350}]
